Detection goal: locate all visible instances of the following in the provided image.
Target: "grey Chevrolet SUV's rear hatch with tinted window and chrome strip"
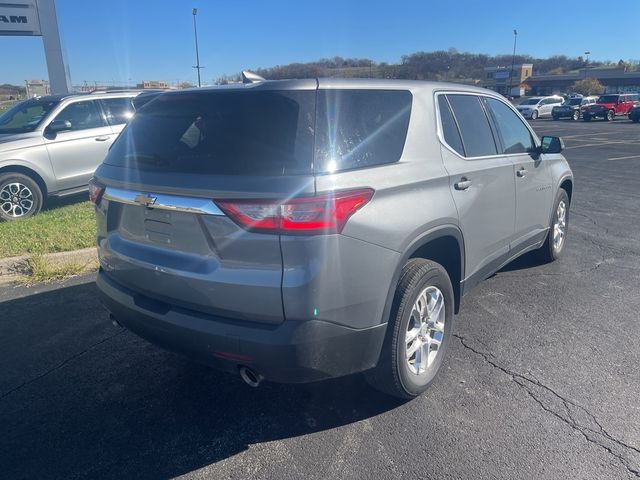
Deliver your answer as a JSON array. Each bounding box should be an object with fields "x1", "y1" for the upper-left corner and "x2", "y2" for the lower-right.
[{"x1": 95, "y1": 80, "x2": 317, "y2": 323}]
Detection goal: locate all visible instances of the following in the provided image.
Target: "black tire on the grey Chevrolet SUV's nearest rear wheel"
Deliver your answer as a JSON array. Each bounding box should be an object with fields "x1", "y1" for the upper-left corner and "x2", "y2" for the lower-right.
[{"x1": 365, "y1": 258, "x2": 454, "y2": 399}]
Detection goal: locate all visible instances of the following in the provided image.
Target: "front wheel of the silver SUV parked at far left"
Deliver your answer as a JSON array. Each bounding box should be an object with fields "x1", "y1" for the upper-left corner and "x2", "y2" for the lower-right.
[{"x1": 0, "y1": 172, "x2": 43, "y2": 222}]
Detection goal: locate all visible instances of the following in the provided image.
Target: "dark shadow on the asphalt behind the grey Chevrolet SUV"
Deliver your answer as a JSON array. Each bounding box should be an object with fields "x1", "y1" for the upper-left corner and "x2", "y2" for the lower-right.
[{"x1": 0, "y1": 283, "x2": 403, "y2": 478}]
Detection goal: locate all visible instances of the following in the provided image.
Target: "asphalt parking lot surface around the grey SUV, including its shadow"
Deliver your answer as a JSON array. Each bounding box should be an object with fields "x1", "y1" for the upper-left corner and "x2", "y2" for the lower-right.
[{"x1": 0, "y1": 119, "x2": 640, "y2": 479}]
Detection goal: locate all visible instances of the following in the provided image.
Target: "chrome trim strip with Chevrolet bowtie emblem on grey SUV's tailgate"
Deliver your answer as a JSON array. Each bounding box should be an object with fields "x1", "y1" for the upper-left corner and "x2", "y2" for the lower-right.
[{"x1": 103, "y1": 187, "x2": 224, "y2": 215}]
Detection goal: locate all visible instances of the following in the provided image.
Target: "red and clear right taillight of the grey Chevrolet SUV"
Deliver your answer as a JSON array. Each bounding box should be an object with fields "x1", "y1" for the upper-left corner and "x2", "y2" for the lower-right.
[{"x1": 216, "y1": 188, "x2": 374, "y2": 235}]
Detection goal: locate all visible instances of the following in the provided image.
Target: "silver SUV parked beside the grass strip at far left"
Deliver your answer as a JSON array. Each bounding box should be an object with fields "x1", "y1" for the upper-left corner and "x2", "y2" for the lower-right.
[{"x1": 0, "y1": 92, "x2": 138, "y2": 221}]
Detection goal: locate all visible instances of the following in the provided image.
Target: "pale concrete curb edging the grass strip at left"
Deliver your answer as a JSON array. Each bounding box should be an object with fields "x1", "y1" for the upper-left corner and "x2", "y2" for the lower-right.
[{"x1": 0, "y1": 247, "x2": 98, "y2": 285}]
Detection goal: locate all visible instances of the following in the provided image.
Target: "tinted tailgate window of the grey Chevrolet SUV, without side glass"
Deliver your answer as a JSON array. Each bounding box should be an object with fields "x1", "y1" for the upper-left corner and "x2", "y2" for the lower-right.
[{"x1": 105, "y1": 91, "x2": 315, "y2": 175}]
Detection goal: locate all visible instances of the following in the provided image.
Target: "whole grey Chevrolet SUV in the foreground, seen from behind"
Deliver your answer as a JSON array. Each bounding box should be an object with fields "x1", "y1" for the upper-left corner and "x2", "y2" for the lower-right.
[{"x1": 90, "y1": 79, "x2": 573, "y2": 398}]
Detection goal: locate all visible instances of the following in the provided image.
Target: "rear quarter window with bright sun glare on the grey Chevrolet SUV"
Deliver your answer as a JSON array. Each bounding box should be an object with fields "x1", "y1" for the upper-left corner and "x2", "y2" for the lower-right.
[{"x1": 315, "y1": 89, "x2": 412, "y2": 173}]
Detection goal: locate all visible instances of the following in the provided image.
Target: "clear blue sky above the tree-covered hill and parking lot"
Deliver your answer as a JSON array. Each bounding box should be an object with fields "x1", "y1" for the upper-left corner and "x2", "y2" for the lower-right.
[{"x1": 0, "y1": 0, "x2": 640, "y2": 85}]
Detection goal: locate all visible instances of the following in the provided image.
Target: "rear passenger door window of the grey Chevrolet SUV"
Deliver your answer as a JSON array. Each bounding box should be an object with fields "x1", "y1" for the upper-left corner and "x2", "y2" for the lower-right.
[{"x1": 447, "y1": 94, "x2": 498, "y2": 157}]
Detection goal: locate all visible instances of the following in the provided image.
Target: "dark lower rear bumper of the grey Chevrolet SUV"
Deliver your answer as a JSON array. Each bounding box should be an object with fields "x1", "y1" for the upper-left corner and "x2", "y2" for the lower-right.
[{"x1": 96, "y1": 270, "x2": 386, "y2": 383}]
